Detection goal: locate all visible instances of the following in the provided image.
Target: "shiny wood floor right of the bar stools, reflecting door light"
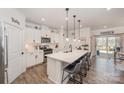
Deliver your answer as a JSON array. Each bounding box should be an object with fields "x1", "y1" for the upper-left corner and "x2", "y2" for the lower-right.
[{"x1": 84, "y1": 57, "x2": 124, "y2": 84}]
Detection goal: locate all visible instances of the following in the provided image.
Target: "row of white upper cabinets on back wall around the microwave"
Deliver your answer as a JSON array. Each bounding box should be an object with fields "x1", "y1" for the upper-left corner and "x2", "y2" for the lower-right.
[{"x1": 25, "y1": 23, "x2": 60, "y2": 43}]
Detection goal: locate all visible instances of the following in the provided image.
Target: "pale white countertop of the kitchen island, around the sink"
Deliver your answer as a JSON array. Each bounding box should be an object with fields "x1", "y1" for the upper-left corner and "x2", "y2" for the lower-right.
[{"x1": 46, "y1": 50, "x2": 88, "y2": 63}]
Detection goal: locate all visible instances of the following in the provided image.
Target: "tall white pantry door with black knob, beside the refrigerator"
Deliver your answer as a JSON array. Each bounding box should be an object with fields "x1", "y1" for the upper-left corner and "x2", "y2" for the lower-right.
[{"x1": 5, "y1": 24, "x2": 25, "y2": 83}]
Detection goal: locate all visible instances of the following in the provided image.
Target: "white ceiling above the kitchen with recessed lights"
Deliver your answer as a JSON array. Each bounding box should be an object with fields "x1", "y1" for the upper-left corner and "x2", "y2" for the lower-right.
[{"x1": 18, "y1": 8, "x2": 124, "y2": 29}]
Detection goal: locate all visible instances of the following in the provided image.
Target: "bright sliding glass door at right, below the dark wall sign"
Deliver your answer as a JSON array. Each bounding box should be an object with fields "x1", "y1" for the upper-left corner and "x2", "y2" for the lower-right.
[{"x1": 96, "y1": 36, "x2": 120, "y2": 56}]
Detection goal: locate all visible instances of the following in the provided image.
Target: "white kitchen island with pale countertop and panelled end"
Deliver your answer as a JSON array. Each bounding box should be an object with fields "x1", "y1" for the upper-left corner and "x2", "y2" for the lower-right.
[{"x1": 47, "y1": 50, "x2": 88, "y2": 84}]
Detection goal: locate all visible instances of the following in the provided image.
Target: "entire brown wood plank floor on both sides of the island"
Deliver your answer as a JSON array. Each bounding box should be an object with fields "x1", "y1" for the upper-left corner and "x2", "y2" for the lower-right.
[{"x1": 13, "y1": 57, "x2": 124, "y2": 84}]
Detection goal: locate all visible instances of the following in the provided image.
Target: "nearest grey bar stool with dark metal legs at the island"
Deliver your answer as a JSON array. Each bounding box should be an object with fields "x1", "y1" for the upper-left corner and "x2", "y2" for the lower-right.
[{"x1": 61, "y1": 60, "x2": 82, "y2": 84}]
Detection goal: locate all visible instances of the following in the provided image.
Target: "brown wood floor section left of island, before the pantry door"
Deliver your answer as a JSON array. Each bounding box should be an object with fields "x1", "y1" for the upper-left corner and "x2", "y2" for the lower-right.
[{"x1": 13, "y1": 63, "x2": 53, "y2": 84}]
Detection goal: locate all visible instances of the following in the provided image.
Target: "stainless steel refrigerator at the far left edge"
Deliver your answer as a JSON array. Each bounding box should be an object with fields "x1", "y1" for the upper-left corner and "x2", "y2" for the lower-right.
[{"x1": 0, "y1": 22, "x2": 8, "y2": 84}]
